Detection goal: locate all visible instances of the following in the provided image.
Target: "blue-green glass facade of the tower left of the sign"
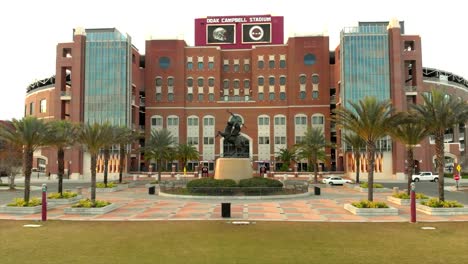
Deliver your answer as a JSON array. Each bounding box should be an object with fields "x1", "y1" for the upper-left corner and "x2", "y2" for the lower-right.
[{"x1": 84, "y1": 28, "x2": 132, "y2": 127}]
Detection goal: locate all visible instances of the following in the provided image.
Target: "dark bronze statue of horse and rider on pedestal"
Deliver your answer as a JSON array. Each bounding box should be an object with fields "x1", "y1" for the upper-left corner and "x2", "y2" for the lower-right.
[{"x1": 218, "y1": 111, "x2": 249, "y2": 158}]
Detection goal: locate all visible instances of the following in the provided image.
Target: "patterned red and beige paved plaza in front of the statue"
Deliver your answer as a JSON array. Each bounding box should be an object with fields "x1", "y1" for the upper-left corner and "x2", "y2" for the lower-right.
[{"x1": 0, "y1": 186, "x2": 468, "y2": 222}]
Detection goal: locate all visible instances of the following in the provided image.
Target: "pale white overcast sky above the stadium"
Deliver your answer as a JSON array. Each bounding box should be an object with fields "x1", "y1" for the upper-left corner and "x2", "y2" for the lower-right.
[{"x1": 0, "y1": 0, "x2": 468, "y2": 120}]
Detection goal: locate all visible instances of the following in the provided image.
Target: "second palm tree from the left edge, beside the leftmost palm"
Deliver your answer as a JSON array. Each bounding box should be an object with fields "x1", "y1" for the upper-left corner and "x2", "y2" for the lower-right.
[{"x1": 47, "y1": 120, "x2": 77, "y2": 195}]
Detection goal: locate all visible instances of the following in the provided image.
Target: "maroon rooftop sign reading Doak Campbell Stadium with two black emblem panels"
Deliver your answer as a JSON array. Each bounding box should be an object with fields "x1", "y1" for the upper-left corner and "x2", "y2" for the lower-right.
[{"x1": 195, "y1": 15, "x2": 284, "y2": 49}]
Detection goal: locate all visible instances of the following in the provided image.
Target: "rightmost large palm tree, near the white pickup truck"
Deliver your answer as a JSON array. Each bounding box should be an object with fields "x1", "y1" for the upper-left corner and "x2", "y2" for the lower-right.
[{"x1": 411, "y1": 89, "x2": 468, "y2": 201}]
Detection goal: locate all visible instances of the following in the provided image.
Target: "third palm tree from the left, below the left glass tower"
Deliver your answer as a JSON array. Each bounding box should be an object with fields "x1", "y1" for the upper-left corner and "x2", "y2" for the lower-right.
[{"x1": 77, "y1": 123, "x2": 109, "y2": 204}]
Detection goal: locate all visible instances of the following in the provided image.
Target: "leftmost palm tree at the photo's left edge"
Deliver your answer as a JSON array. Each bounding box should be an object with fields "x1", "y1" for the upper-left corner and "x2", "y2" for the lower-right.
[{"x1": 0, "y1": 116, "x2": 49, "y2": 204}]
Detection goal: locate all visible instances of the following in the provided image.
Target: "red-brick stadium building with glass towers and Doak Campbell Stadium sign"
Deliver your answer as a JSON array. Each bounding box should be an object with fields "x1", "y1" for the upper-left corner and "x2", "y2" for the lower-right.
[{"x1": 25, "y1": 15, "x2": 468, "y2": 179}]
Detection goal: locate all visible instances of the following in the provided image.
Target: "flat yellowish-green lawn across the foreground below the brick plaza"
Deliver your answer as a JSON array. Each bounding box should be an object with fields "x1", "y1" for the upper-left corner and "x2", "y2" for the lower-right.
[{"x1": 0, "y1": 221, "x2": 468, "y2": 264}]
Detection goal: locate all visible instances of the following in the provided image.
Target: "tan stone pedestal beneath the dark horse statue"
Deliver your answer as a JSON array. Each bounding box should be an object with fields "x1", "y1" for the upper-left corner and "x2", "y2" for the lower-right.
[{"x1": 214, "y1": 158, "x2": 253, "y2": 182}]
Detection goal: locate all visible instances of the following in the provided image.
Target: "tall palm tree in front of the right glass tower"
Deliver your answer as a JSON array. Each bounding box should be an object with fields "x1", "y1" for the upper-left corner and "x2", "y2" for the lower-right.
[{"x1": 333, "y1": 97, "x2": 393, "y2": 201}]
